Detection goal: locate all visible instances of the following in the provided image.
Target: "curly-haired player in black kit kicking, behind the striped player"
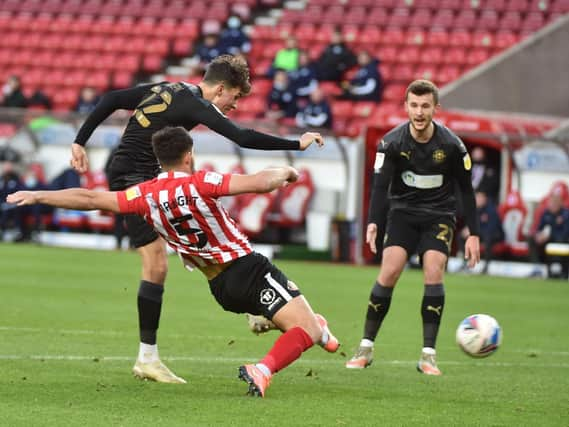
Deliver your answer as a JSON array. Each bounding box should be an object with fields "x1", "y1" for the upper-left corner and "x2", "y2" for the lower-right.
[{"x1": 71, "y1": 55, "x2": 323, "y2": 384}]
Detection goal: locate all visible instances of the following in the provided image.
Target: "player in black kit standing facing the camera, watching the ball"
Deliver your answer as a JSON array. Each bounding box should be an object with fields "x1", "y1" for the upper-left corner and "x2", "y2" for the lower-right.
[{"x1": 346, "y1": 80, "x2": 480, "y2": 375}]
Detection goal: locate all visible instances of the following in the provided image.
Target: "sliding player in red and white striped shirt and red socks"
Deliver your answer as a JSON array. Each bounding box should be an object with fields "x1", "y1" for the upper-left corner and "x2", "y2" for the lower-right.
[{"x1": 7, "y1": 127, "x2": 339, "y2": 397}]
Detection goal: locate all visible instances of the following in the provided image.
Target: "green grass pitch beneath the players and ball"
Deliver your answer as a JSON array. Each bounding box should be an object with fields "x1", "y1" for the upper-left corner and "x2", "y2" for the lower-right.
[{"x1": 0, "y1": 244, "x2": 569, "y2": 427}]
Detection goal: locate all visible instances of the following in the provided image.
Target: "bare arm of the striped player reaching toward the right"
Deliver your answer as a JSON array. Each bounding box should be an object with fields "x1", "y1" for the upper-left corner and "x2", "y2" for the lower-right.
[{"x1": 228, "y1": 166, "x2": 298, "y2": 195}]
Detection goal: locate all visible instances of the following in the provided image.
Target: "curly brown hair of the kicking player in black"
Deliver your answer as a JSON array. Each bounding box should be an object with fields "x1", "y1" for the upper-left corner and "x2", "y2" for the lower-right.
[{"x1": 203, "y1": 55, "x2": 251, "y2": 95}]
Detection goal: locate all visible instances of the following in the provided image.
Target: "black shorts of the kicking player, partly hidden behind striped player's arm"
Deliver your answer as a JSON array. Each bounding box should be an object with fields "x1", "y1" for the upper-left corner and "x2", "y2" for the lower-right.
[{"x1": 108, "y1": 156, "x2": 159, "y2": 248}]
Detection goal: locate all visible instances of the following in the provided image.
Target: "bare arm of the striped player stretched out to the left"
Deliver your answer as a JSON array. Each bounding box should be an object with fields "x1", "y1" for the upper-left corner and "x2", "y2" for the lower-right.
[{"x1": 6, "y1": 188, "x2": 120, "y2": 212}]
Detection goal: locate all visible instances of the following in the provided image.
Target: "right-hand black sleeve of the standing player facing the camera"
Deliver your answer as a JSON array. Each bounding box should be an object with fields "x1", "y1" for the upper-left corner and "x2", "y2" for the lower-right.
[{"x1": 454, "y1": 137, "x2": 480, "y2": 236}]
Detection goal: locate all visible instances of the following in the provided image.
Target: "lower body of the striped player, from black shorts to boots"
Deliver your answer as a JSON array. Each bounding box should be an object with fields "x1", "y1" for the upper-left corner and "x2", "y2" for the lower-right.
[{"x1": 220, "y1": 253, "x2": 339, "y2": 396}]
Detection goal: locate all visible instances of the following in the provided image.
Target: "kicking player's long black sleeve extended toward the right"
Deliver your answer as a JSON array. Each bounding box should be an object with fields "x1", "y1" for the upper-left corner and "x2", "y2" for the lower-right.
[{"x1": 182, "y1": 98, "x2": 300, "y2": 150}]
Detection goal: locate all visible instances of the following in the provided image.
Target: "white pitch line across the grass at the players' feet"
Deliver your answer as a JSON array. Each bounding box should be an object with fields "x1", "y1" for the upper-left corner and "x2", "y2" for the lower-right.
[{"x1": 0, "y1": 354, "x2": 569, "y2": 369}]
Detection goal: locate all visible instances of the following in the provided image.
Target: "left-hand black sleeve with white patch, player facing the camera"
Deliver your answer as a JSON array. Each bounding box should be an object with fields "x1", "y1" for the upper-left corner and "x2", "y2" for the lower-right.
[{"x1": 368, "y1": 140, "x2": 394, "y2": 230}]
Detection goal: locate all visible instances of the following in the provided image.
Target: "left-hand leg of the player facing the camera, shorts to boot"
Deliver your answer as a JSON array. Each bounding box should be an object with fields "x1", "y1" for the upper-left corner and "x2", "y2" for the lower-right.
[{"x1": 346, "y1": 213, "x2": 418, "y2": 369}]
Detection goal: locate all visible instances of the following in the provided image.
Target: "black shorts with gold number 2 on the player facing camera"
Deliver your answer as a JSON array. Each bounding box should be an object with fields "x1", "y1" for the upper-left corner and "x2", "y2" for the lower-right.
[{"x1": 383, "y1": 209, "x2": 456, "y2": 257}]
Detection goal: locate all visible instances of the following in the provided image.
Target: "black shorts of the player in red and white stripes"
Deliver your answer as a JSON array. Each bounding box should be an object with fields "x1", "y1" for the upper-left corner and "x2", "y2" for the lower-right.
[{"x1": 209, "y1": 252, "x2": 300, "y2": 319}]
